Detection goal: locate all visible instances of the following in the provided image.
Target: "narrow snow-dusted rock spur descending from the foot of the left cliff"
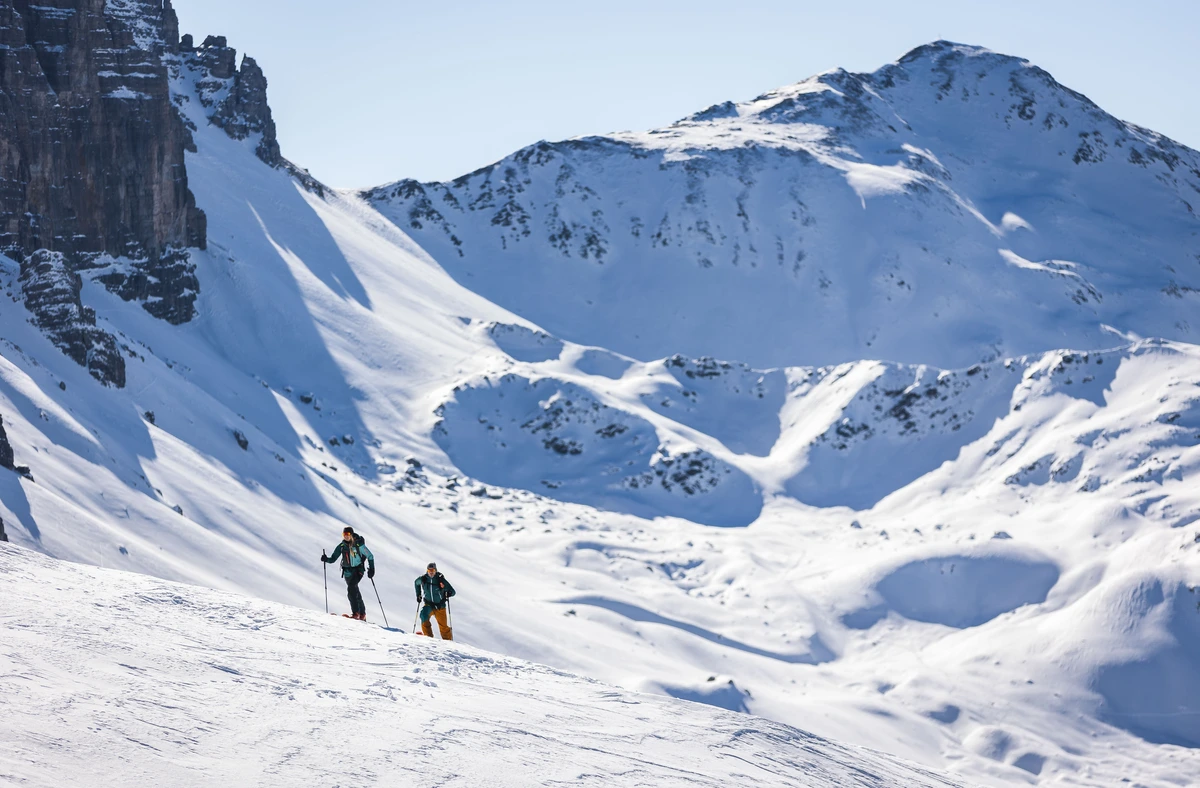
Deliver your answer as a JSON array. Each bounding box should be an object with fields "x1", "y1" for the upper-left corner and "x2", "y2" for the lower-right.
[{"x1": 19, "y1": 249, "x2": 125, "y2": 386}]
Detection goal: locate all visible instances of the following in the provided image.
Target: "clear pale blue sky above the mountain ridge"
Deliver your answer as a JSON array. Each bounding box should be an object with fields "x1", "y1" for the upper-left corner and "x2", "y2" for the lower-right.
[{"x1": 174, "y1": 0, "x2": 1200, "y2": 186}]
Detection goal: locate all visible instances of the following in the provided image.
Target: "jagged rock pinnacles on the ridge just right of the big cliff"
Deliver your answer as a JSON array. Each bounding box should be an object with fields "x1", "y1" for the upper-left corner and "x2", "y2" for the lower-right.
[{"x1": 180, "y1": 36, "x2": 286, "y2": 167}]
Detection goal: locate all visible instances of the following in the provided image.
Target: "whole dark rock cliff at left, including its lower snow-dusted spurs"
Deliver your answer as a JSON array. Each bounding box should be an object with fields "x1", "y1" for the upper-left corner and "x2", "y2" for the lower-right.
[{"x1": 0, "y1": 0, "x2": 206, "y2": 386}]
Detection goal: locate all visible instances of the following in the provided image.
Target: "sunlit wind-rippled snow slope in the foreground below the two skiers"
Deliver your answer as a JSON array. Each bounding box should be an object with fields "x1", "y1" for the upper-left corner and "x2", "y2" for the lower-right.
[{"x1": 0, "y1": 545, "x2": 962, "y2": 788}]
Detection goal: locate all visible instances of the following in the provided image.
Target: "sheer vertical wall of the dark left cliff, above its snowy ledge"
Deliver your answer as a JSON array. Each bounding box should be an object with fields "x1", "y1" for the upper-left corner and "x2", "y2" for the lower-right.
[{"x1": 0, "y1": 0, "x2": 205, "y2": 260}]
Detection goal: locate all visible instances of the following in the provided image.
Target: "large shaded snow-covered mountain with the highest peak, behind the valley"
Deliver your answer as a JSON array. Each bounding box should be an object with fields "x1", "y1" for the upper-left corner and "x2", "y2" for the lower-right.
[{"x1": 366, "y1": 42, "x2": 1200, "y2": 367}]
